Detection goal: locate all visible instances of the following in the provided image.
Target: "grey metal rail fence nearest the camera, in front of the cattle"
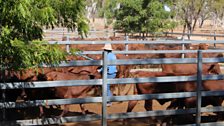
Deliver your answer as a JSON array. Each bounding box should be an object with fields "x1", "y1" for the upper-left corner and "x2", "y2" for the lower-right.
[{"x1": 0, "y1": 41, "x2": 224, "y2": 126}]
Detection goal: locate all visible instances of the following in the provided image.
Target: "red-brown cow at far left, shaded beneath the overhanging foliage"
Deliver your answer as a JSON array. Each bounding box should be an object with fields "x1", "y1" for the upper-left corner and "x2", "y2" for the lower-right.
[{"x1": 0, "y1": 68, "x2": 89, "y2": 116}]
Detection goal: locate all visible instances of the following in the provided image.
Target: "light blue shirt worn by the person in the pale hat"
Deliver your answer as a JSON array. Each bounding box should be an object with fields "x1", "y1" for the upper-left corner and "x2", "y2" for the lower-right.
[{"x1": 100, "y1": 52, "x2": 117, "y2": 74}]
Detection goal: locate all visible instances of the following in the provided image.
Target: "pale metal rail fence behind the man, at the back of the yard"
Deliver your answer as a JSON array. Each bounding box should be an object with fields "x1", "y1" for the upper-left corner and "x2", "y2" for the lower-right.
[{"x1": 48, "y1": 33, "x2": 224, "y2": 54}]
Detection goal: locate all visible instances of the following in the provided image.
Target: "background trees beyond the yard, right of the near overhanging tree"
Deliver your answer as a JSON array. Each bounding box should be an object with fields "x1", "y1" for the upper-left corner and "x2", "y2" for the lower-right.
[{"x1": 88, "y1": 0, "x2": 224, "y2": 35}]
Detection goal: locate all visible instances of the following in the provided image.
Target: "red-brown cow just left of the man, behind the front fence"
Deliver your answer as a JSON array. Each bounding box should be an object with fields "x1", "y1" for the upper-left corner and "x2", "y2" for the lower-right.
[{"x1": 19, "y1": 66, "x2": 101, "y2": 117}]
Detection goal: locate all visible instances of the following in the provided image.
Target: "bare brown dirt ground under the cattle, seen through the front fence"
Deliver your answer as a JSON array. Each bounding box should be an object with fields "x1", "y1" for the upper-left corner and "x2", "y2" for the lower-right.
[{"x1": 48, "y1": 90, "x2": 220, "y2": 126}]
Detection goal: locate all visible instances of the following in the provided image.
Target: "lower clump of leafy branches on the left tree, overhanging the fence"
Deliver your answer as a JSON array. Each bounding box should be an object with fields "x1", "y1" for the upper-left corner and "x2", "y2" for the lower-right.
[{"x1": 0, "y1": 28, "x2": 66, "y2": 70}]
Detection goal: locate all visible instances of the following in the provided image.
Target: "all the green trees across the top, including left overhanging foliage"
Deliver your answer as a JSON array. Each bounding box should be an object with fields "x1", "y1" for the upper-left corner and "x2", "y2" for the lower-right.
[{"x1": 0, "y1": 0, "x2": 224, "y2": 70}]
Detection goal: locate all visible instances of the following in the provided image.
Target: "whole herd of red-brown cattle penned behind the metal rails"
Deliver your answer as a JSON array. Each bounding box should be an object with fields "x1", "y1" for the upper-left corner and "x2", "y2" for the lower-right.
[{"x1": 0, "y1": 36, "x2": 224, "y2": 124}]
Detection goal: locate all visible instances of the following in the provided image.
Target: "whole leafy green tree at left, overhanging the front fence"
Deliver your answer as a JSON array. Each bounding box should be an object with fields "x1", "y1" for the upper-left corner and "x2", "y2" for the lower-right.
[{"x1": 0, "y1": 0, "x2": 89, "y2": 70}]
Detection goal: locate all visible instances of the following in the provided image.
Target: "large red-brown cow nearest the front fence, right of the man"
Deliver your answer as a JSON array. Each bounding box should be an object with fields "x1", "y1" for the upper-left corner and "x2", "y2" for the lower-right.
[{"x1": 127, "y1": 71, "x2": 224, "y2": 124}]
